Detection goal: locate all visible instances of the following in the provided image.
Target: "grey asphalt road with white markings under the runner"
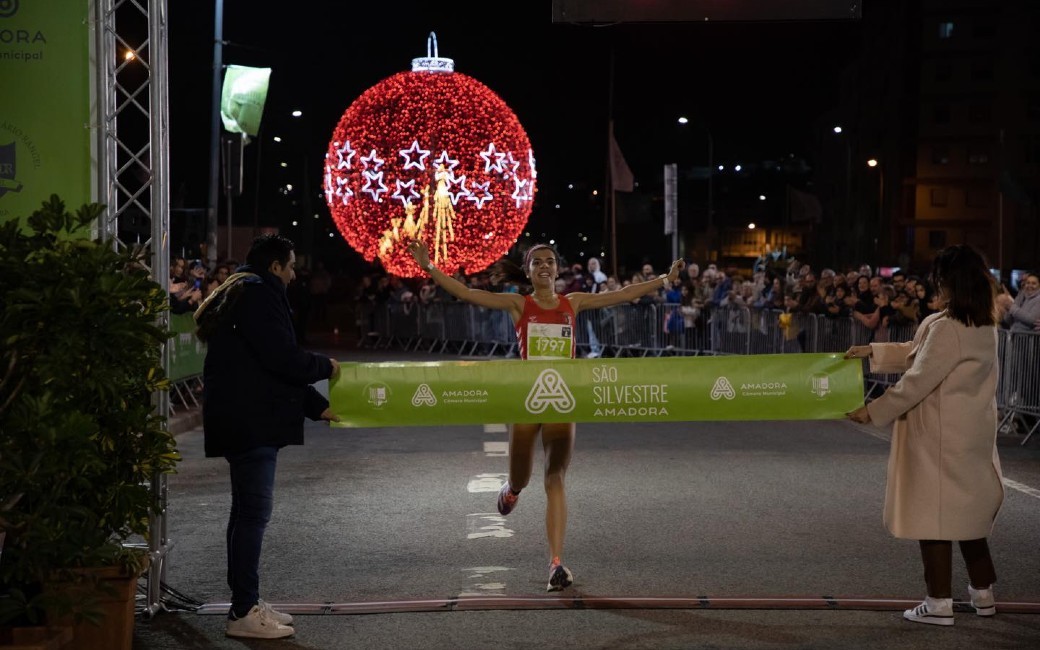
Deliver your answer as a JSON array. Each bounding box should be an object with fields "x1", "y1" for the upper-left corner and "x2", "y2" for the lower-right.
[{"x1": 134, "y1": 353, "x2": 1040, "y2": 650}]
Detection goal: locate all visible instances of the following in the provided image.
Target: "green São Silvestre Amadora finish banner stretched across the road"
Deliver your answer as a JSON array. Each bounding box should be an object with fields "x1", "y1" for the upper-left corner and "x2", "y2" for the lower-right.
[{"x1": 329, "y1": 354, "x2": 863, "y2": 427}]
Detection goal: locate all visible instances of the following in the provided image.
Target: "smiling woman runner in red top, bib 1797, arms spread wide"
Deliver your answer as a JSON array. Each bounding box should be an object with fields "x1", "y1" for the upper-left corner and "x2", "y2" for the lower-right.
[{"x1": 408, "y1": 241, "x2": 685, "y2": 592}]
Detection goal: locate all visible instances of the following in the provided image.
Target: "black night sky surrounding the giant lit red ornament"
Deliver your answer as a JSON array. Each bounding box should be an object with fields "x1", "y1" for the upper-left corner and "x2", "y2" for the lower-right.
[{"x1": 168, "y1": 0, "x2": 860, "y2": 268}]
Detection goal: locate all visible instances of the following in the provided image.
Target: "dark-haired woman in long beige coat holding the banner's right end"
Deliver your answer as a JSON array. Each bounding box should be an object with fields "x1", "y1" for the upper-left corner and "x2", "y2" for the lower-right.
[{"x1": 846, "y1": 245, "x2": 1004, "y2": 625}]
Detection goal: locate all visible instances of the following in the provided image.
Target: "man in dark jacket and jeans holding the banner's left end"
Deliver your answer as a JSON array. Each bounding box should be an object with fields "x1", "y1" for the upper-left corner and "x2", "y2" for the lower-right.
[{"x1": 196, "y1": 235, "x2": 339, "y2": 639}]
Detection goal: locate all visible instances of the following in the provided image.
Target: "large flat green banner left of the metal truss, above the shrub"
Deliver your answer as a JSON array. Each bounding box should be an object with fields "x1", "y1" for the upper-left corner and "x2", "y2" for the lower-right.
[{"x1": 0, "y1": 0, "x2": 93, "y2": 222}]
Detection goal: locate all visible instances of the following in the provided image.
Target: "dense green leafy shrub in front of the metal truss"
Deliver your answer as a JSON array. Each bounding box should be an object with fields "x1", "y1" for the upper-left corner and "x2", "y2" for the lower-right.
[{"x1": 0, "y1": 196, "x2": 180, "y2": 647}]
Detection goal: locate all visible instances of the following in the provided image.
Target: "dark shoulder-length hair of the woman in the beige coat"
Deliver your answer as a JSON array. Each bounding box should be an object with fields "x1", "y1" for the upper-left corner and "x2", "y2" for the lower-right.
[{"x1": 932, "y1": 244, "x2": 996, "y2": 328}]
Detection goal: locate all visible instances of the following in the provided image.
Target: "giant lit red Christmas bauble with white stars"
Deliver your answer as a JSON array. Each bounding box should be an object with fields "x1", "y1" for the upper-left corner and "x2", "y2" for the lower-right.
[{"x1": 324, "y1": 34, "x2": 537, "y2": 278}]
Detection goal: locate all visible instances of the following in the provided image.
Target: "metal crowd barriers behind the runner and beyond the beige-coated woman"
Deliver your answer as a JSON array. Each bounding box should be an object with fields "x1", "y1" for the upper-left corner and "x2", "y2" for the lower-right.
[{"x1": 358, "y1": 302, "x2": 1040, "y2": 444}]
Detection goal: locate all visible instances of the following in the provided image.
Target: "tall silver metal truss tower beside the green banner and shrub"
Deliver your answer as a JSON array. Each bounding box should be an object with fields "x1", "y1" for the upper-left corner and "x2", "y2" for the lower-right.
[{"x1": 90, "y1": 0, "x2": 171, "y2": 616}]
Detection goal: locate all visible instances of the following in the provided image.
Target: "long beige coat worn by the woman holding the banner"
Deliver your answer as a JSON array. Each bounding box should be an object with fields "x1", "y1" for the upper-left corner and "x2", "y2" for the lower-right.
[{"x1": 866, "y1": 312, "x2": 1004, "y2": 540}]
